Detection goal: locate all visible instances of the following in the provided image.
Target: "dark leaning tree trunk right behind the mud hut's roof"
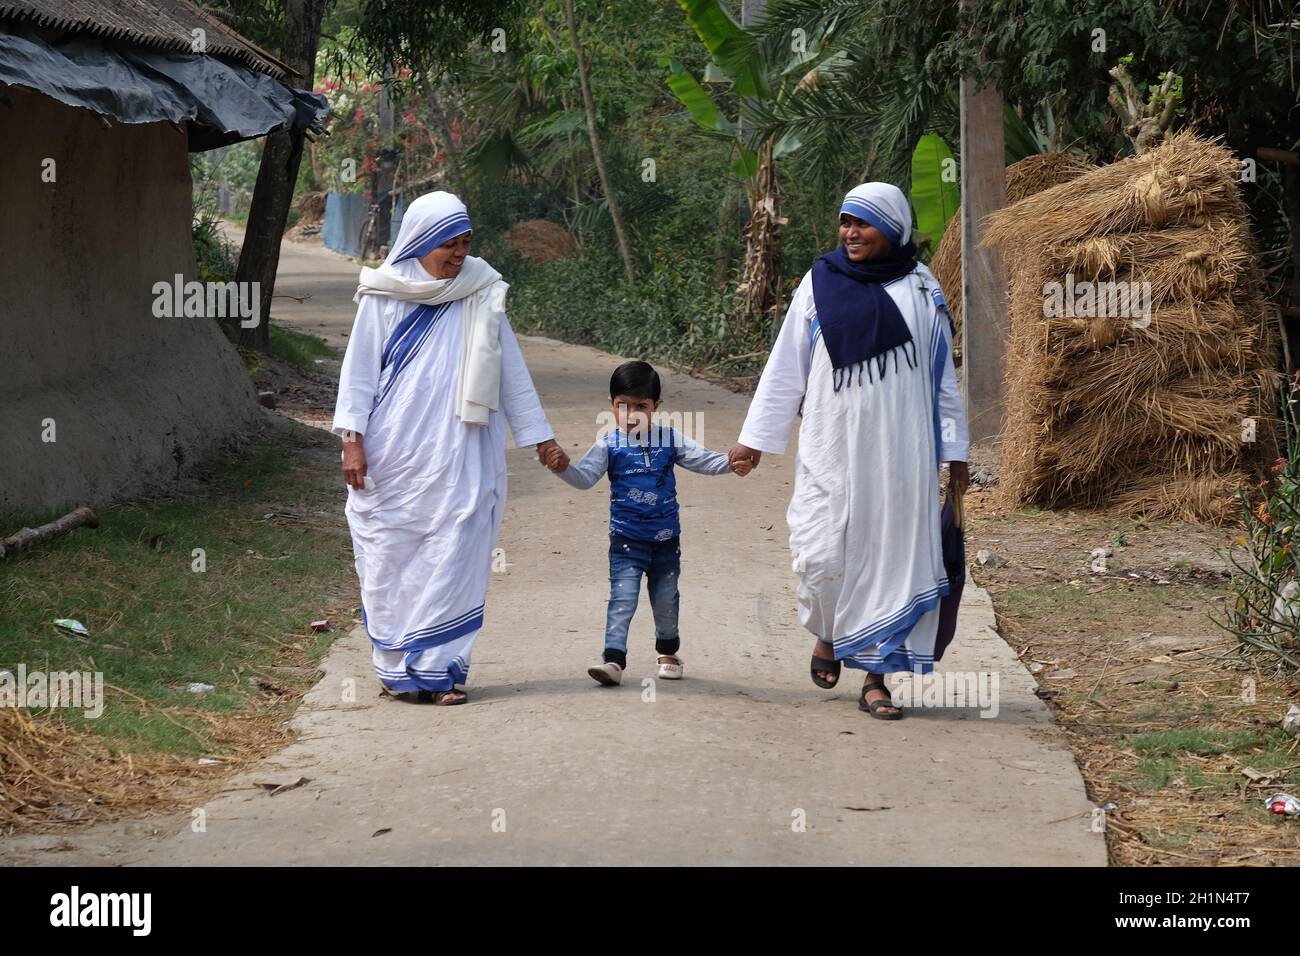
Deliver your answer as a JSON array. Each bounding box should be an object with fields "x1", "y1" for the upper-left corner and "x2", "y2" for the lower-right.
[{"x1": 235, "y1": 0, "x2": 326, "y2": 351}]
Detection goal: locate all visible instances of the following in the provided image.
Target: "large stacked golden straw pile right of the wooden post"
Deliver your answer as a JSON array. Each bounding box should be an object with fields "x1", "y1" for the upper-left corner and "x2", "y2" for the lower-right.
[{"x1": 987, "y1": 133, "x2": 1281, "y2": 523}]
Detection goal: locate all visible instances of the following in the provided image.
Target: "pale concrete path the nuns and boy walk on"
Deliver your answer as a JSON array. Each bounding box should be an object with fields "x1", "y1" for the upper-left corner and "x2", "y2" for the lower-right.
[{"x1": 7, "y1": 231, "x2": 1106, "y2": 865}]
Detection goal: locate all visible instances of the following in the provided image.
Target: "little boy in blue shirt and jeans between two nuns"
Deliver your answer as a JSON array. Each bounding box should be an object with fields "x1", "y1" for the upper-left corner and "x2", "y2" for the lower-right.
[{"x1": 546, "y1": 362, "x2": 751, "y2": 687}]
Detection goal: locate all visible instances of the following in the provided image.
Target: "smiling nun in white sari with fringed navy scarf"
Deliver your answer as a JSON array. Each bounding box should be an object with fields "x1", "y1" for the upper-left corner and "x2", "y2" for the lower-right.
[{"x1": 731, "y1": 182, "x2": 970, "y2": 719}]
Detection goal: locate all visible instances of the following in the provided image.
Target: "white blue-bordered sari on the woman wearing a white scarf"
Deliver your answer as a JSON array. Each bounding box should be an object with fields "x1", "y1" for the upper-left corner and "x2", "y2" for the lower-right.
[{"x1": 334, "y1": 260, "x2": 554, "y2": 691}]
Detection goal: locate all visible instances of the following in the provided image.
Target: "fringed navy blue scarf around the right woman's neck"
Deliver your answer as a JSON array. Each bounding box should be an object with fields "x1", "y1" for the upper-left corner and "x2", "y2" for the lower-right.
[{"x1": 813, "y1": 242, "x2": 917, "y2": 392}]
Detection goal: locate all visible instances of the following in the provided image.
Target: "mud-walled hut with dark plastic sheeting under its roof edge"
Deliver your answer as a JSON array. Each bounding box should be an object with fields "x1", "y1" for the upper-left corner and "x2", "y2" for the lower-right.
[{"x1": 0, "y1": 0, "x2": 325, "y2": 515}]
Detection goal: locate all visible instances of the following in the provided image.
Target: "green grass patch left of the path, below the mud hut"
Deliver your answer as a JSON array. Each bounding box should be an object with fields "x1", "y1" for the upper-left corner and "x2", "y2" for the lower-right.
[{"x1": 0, "y1": 433, "x2": 352, "y2": 753}]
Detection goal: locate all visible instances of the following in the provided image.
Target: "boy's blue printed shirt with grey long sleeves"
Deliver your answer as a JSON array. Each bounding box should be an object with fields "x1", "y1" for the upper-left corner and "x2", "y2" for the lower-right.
[{"x1": 560, "y1": 427, "x2": 731, "y2": 541}]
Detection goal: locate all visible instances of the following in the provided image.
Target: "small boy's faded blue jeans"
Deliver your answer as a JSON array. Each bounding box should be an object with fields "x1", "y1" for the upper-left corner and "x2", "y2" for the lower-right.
[{"x1": 605, "y1": 535, "x2": 681, "y2": 667}]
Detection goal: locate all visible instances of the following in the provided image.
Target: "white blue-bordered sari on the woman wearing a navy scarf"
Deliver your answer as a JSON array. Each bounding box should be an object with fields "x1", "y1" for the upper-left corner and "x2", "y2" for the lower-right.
[{"x1": 740, "y1": 265, "x2": 969, "y2": 674}]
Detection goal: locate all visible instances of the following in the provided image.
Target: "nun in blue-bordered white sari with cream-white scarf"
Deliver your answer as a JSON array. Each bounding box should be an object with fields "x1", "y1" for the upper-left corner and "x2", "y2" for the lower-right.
[{"x1": 333, "y1": 193, "x2": 567, "y2": 704}]
